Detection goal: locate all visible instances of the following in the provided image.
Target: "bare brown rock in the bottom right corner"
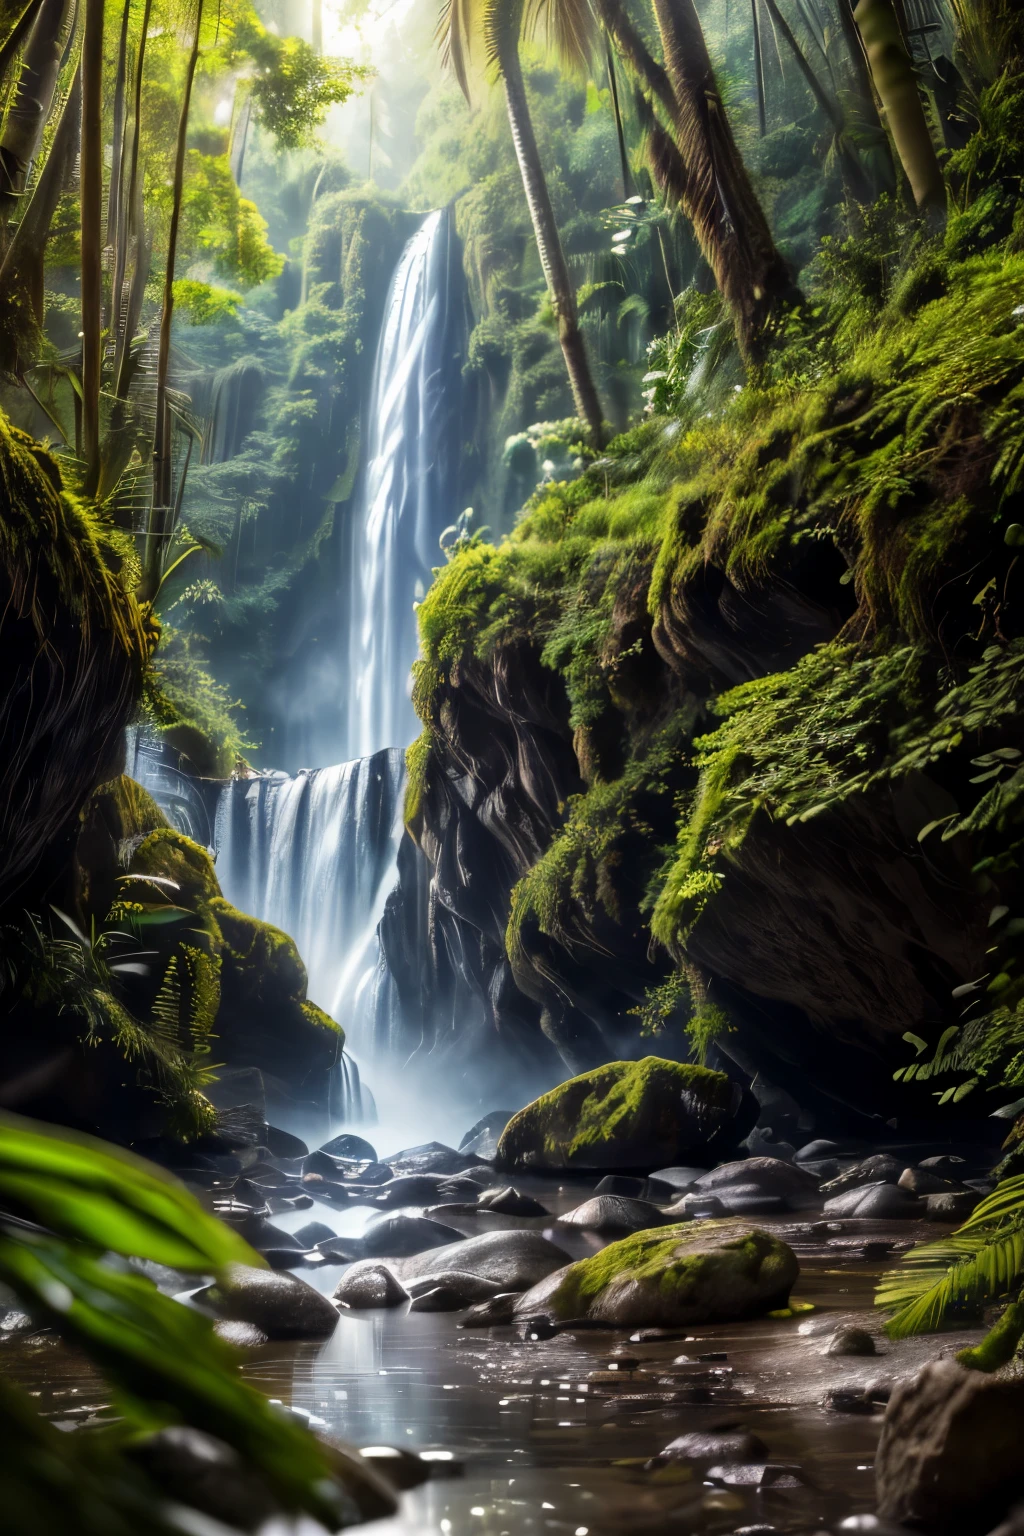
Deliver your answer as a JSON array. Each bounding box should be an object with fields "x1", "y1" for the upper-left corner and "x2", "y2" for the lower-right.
[{"x1": 875, "y1": 1359, "x2": 1024, "y2": 1536}]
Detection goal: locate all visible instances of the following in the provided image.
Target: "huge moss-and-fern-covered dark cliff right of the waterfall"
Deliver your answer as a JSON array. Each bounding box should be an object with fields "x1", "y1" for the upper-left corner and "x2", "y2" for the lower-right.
[{"x1": 408, "y1": 162, "x2": 1024, "y2": 1124}]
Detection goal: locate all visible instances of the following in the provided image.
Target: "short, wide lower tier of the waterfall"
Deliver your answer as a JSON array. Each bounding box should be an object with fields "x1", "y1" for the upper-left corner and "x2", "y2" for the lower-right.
[{"x1": 213, "y1": 750, "x2": 405, "y2": 1051}]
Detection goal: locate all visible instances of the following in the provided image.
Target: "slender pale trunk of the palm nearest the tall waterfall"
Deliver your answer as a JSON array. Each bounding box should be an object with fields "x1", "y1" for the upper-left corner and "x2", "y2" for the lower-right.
[{"x1": 496, "y1": 0, "x2": 605, "y2": 447}]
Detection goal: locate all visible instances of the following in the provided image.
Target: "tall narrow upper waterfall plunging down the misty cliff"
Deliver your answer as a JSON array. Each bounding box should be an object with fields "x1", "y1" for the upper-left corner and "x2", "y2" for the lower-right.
[{"x1": 347, "y1": 209, "x2": 467, "y2": 757}]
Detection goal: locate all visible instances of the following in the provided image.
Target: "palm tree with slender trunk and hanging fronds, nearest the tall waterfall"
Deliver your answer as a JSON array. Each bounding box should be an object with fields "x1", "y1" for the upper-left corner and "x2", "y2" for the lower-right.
[{"x1": 439, "y1": 0, "x2": 605, "y2": 445}]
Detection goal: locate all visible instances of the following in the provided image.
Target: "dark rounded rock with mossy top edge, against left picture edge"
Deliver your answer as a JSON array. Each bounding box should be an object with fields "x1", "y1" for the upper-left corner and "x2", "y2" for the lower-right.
[{"x1": 0, "y1": 416, "x2": 147, "y2": 911}]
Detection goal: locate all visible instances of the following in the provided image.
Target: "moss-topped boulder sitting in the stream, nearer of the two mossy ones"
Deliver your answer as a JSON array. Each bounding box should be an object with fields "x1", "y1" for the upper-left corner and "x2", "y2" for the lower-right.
[{"x1": 516, "y1": 1221, "x2": 800, "y2": 1327}]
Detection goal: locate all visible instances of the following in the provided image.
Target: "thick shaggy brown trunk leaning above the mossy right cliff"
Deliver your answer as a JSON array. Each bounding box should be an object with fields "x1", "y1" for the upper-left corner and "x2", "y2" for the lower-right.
[{"x1": 654, "y1": 0, "x2": 798, "y2": 361}]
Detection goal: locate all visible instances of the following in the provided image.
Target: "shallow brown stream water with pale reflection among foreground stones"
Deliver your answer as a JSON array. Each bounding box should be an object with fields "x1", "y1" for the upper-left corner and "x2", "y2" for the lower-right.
[{"x1": 3, "y1": 1178, "x2": 978, "y2": 1536}]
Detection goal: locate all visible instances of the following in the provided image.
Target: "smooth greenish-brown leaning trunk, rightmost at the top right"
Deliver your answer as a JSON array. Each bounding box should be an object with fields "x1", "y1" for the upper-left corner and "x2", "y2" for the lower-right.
[{"x1": 854, "y1": 0, "x2": 946, "y2": 210}]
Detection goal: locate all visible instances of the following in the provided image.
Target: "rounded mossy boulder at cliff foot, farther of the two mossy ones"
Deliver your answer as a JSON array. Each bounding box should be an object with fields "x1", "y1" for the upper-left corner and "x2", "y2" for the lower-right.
[{"x1": 497, "y1": 1057, "x2": 742, "y2": 1170}]
